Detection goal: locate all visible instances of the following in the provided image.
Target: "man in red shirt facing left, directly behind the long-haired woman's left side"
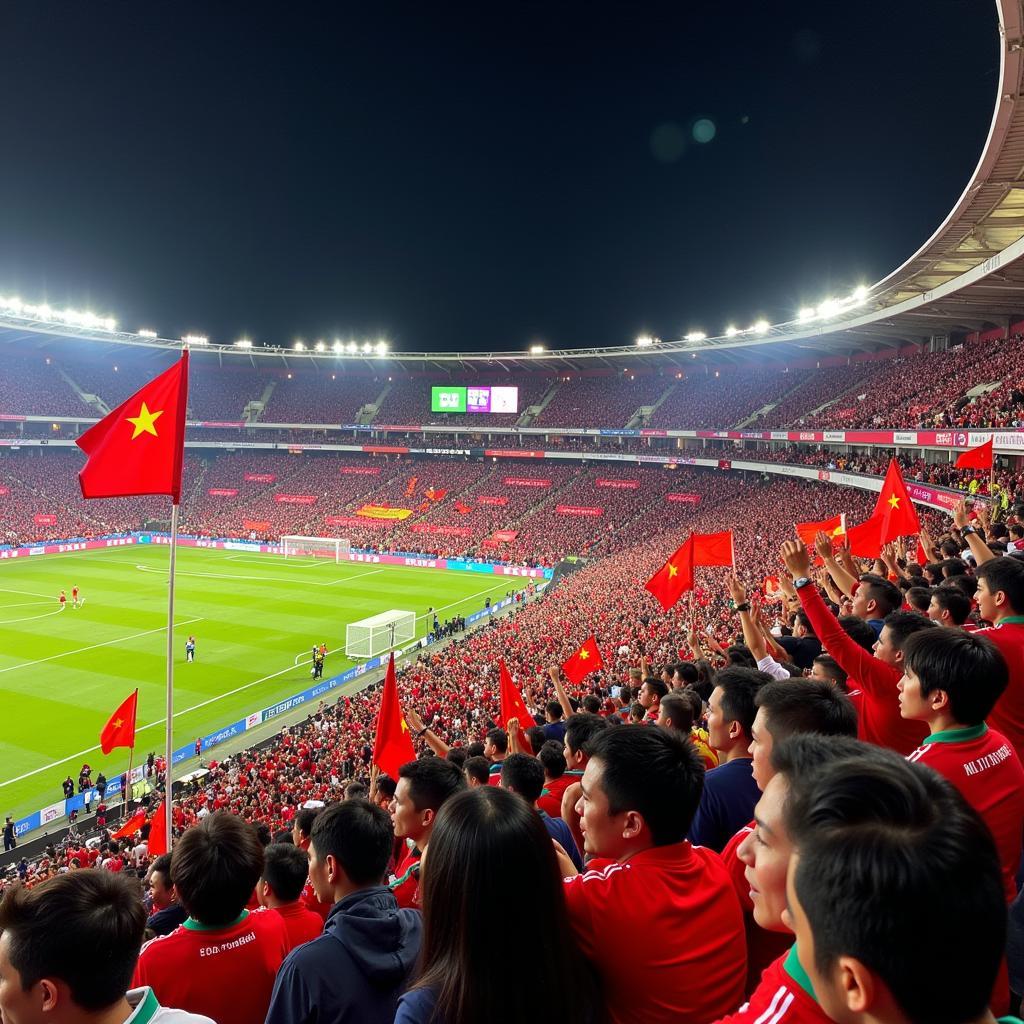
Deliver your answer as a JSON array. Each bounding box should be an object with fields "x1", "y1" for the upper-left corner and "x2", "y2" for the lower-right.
[{"x1": 388, "y1": 758, "x2": 468, "y2": 907}]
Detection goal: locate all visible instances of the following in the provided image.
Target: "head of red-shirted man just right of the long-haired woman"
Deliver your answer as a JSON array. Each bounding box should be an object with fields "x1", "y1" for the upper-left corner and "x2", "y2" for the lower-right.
[{"x1": 575, "y1": 728, "x2": 703, "y2": 860}]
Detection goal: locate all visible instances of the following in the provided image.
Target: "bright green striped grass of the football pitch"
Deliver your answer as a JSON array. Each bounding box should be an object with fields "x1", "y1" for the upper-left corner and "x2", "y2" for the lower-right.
[{"x1": 0, "y1": 546, "x2": 516, "y2": 817}]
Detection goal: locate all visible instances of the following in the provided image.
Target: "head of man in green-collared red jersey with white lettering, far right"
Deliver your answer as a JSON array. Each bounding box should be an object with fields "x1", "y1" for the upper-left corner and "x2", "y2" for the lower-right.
[{"x1": 899, "y1": 630, "x2": 1010, "y2": 728}]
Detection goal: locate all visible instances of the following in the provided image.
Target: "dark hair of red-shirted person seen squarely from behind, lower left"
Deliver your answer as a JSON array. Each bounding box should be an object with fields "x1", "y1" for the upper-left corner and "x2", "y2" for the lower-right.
[{"x1": 171, "y1": 811, "x2": 264, "y2": 928}]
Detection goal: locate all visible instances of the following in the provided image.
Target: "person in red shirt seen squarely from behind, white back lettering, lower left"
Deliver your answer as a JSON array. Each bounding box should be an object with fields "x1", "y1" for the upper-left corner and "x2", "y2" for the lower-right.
[{"x1": 132, "y1": 811, "x2": 289, "y2": 1024}]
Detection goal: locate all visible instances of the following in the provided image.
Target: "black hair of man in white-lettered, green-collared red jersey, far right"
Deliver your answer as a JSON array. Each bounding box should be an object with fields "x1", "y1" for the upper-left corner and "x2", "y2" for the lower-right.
[{"x1": 903, "y1": 630, "x2": 1010, "y2": 725}]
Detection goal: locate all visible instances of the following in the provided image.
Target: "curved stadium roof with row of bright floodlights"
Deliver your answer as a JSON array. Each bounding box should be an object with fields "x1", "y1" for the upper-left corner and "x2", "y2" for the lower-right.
[{"x1": 0, "y1": 0, "x2": 1024, "y2": 374}]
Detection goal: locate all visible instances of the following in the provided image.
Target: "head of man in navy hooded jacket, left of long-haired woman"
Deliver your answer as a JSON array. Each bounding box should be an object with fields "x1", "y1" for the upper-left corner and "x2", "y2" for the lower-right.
[{"x1": 309, "y1": 800, "x2": 394, "y2": 903}]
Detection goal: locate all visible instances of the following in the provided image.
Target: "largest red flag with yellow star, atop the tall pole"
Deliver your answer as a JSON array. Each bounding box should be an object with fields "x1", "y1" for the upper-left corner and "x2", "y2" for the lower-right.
[{"x1": 75, "y1": 351, "x2": 188, "y2": 505}]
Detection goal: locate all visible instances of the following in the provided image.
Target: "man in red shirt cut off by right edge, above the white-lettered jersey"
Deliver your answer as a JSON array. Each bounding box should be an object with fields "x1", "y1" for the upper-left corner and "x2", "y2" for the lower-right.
[{"x1": 971, "y1": 557, "x2": 1024, "y2": 762}]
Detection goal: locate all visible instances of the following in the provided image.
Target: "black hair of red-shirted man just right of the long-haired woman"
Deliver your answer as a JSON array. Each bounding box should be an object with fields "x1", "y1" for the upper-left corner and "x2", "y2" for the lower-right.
[{"x1": 591, "y1": 728, "x2": 705, "y2": 846}]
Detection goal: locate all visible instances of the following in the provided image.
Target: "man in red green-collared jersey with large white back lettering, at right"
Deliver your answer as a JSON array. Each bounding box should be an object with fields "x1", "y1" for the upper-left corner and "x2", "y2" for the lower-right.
[{"x1": 899, "y1": 630, "x2": 1024, "y2": 902}]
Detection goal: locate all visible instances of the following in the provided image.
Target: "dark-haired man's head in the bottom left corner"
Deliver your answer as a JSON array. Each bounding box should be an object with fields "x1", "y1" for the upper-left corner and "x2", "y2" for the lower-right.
[{"x1": 0, "y1": 870, "x2": 145, "y2": 1024}]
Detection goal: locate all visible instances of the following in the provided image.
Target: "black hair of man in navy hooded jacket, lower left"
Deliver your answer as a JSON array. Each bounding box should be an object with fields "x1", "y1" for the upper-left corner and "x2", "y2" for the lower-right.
[{"x1": 310, "y1": 800, "x2": 394, "y2": 887}]
